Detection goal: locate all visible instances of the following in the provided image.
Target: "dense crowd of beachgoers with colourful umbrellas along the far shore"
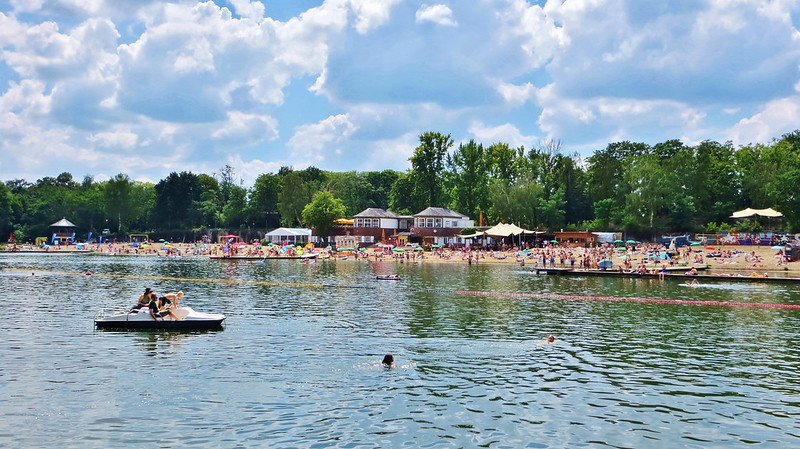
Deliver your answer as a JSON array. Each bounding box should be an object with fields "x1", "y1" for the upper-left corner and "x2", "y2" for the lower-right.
[{"x1": 23, "y1": 234, "x2": 795, "y2": 274}]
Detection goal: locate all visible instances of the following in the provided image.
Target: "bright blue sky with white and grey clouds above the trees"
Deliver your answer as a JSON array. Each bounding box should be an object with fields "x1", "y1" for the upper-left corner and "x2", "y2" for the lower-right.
[{"x1": 0, "y1": 0, "x2": 800, "y2": 187}]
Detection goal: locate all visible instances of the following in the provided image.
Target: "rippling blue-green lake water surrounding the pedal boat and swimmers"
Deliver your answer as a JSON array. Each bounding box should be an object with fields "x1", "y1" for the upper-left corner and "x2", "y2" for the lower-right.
[{"x1": 0, "y1": 254, "x2": 800, "y2": 448}]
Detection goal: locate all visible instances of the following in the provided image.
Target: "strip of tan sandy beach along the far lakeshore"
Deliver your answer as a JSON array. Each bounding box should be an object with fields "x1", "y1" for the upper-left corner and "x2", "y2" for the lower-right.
[{"x1": 5, "y1": 243, "x2": 800, "y2": 277}]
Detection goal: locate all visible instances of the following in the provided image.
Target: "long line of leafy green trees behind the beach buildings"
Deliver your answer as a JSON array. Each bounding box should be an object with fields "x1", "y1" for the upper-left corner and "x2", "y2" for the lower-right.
[{"x1": 0, "y1": 130, "x2": 800, "y2": 241}]
